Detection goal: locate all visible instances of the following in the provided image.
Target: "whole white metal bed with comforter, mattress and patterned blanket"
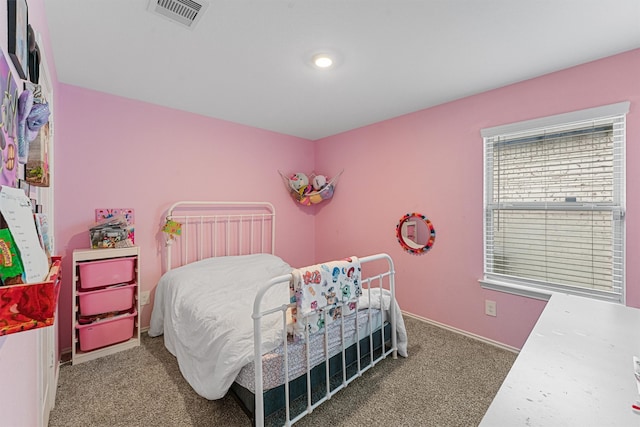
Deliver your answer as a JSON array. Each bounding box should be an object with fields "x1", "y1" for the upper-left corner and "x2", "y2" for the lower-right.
[{"x1": 149, "y1": 201, "x2": 407, "y2": 426}]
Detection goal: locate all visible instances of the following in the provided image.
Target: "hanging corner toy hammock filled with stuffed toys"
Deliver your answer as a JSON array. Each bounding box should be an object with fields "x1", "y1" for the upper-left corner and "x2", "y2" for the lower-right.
[{"x1": 278, "y1": 171, "x2": 344, "y2": 206}]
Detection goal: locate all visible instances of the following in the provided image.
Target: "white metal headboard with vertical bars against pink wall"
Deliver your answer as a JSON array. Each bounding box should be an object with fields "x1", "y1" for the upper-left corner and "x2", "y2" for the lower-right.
[{"x1": 165, "y1": 201, "x2": 276, "y2": 271}]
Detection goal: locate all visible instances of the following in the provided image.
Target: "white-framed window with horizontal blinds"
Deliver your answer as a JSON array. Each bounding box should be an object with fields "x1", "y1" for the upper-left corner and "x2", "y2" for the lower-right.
[{"x1": 480, "y1": 102, "x2": 629, "y2": 303}]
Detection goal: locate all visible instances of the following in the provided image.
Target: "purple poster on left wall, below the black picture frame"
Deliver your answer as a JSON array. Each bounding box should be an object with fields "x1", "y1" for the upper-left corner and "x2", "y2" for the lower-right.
[{"x1": 0, "y1": 47, "x2": 20, "y2": 187}]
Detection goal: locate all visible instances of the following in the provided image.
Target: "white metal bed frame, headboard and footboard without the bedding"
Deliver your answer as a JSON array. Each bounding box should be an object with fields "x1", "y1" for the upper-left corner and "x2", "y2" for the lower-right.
[{"x1": 166, "y1": 201, "x2": 397, "y2": 427}]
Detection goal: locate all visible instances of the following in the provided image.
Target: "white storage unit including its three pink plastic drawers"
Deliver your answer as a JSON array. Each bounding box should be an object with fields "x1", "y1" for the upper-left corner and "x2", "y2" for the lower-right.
[{"x1": 71, "y1": 246, "x2": 140, "y2": 364}]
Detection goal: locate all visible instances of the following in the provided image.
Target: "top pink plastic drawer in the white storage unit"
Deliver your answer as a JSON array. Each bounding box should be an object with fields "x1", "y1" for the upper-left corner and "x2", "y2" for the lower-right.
[{"x1": 78, "y1": 257, "x2": 136, "y2": 289}]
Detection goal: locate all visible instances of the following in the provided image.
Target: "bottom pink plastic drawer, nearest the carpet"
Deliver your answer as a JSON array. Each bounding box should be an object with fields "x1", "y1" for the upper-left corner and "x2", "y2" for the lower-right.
[{"x1": 76, "y1": 310, "x2": 137, "y2": 351}]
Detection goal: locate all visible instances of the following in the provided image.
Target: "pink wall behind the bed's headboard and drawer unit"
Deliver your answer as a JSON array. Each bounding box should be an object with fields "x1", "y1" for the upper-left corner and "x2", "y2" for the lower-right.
[{"x1": 55, "y1": 84, "x2": 315, "y2": 349}]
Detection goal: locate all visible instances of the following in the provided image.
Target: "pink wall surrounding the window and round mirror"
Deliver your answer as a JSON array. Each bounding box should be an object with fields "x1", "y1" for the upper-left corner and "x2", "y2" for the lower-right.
[{"x1": 315, "y1": 50, "x2": 640, "y2": 348}]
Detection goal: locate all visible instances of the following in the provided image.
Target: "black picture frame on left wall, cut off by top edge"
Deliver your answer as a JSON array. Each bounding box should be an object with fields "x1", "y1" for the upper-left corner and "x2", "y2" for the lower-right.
[{"x1": 7, "y1": 0, "x2": 29, "y2": 79}]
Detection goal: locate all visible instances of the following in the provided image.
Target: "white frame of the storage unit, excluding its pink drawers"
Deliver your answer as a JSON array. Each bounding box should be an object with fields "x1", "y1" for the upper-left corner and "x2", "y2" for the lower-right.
[{"x1": 71, "y1": 246, "x2": 140, "y2": 365}]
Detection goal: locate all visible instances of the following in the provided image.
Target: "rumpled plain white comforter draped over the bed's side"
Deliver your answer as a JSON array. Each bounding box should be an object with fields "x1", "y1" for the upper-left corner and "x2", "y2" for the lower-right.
[{"x1": 149, "y1": 254, "x2": 291, "y2": 400}]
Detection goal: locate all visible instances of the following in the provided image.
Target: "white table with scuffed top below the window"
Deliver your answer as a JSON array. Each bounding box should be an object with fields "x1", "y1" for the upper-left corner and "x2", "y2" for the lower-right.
[{"x1": 480, "y1": 294, "x2": 640, "y2": 427}]
